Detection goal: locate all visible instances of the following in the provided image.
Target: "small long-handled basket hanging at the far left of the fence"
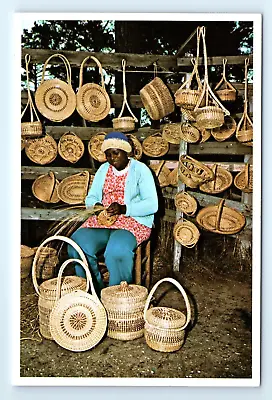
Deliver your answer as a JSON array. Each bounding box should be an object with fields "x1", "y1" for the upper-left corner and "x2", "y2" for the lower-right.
[{"x1": 21, "y1": 54, "x2": 43, "y2": 138}]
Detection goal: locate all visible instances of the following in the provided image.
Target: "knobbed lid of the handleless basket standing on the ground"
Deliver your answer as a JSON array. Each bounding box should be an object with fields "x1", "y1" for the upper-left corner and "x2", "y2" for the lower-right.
[{"x1": 101, "y1": 281, "x2": 148, "y2": 307}]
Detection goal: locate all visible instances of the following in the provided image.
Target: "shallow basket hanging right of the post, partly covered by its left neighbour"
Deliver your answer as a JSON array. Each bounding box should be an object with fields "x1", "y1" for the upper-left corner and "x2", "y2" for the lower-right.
[{"x1": 199, "y1": 164, "x2": 233, "y2": 194}]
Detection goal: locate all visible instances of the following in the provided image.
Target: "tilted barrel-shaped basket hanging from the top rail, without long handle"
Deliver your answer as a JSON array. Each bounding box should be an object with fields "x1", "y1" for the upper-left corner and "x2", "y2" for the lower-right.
[{"x1": 140, "y1": 77, "x2": 175, "y2": 121}]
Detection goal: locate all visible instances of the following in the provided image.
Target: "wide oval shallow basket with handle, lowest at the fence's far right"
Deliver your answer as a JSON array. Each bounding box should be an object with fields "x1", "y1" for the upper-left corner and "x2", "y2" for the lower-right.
[{"x1": 196, "y1": 199, "x2": 246, "y2": 235}]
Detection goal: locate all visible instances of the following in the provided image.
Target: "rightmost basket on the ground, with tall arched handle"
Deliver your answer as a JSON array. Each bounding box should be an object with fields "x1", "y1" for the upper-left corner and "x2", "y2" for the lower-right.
[{"x1": 144, "y1": 278, "x2": 191, "y2": 353}]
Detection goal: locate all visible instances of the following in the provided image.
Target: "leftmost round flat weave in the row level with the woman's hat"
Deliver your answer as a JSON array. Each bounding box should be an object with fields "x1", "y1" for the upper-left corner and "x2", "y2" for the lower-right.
[{"x1": 25, "y1": 134, "x2": 58, "y2": 165}]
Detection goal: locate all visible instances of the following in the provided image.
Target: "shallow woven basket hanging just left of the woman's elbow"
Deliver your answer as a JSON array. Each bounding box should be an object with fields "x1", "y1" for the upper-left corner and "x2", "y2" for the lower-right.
[{"x1": 57, "y1": 171, "x2": 89, "y2": 204}]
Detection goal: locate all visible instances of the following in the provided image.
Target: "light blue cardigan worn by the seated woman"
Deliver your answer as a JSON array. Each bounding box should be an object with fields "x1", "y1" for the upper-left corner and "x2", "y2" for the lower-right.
[{"x1": 85, "y1": 158, "x2": 158, "y2": 228}]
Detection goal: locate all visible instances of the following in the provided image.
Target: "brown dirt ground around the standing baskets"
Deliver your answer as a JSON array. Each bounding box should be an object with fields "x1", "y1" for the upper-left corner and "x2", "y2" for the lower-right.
[{"x1": 20, "y1": 234, "x2": 252, "y2": 378}]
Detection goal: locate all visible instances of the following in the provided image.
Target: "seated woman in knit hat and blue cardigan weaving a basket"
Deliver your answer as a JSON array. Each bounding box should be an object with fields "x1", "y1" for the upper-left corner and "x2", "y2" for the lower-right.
[{"x1": 68, "y1": 132, "x2": 158, "y2": 291}]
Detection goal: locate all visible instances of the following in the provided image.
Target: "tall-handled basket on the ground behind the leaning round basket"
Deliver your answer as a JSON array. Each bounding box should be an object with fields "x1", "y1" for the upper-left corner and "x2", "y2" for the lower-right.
[{"x1": 32, "y1": 235, "x2": 88, "y2": 340}]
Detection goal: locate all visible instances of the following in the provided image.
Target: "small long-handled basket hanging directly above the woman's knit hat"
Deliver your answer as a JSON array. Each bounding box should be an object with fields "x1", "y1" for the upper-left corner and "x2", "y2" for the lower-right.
[{"x1": 112, "y1": 59, "x2": 138, "y2": 132}]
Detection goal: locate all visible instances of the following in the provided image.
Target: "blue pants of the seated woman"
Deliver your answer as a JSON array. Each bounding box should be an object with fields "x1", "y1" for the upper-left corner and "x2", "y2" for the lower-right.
[{"x1": 68, "y1": 228, "x2": 137, "y2": 294}]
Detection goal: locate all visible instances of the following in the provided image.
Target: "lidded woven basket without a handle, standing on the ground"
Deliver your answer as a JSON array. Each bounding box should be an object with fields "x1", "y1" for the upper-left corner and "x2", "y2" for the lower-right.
[{"x1": 101, "y1": 281, "x2": 148, "y2": 340}]
